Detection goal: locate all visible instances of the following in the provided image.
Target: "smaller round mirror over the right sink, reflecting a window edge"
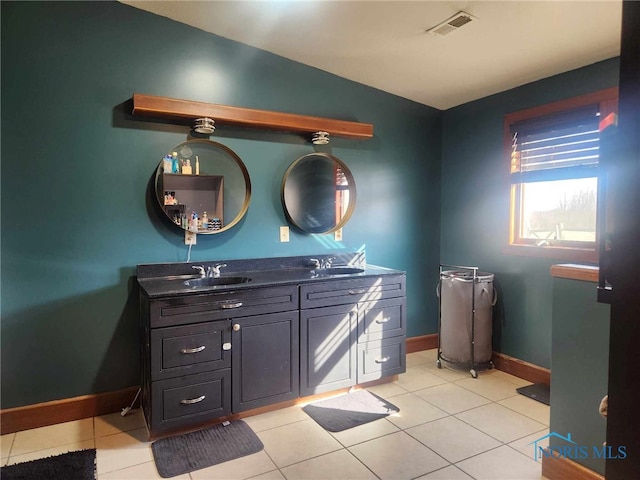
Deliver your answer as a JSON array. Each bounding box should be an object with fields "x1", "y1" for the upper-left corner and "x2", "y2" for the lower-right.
[{"x1": 282, "y1": 153, "x2": 356, "y2": 233}]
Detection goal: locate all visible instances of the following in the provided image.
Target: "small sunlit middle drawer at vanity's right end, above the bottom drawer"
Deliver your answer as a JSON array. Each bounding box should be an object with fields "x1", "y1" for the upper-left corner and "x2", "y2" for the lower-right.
[{"x1": 358, "y1": 298, "x2": 407, "y2": 343}]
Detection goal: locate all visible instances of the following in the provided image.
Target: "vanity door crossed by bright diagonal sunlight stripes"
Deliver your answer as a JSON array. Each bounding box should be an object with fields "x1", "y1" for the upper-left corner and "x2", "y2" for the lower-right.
[{"x1": 300, "y1": 305, "x2": 357, "y2": 396}]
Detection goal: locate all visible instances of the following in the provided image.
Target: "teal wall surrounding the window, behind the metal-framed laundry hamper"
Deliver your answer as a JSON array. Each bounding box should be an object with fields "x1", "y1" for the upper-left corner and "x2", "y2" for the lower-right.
[{"x1": 440, "y1": 58, "x2": 619, "y2": 368}]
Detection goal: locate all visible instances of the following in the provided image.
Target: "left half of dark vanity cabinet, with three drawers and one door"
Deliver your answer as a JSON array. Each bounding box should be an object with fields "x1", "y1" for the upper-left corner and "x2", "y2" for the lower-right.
[{"x1": 140, "y1": 285, "x2": 299, "y2": 435}]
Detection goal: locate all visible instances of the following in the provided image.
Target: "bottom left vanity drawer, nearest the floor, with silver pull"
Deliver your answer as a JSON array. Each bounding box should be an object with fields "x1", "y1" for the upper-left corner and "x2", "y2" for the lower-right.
[{"x1": 151, "y1": 368, "x2": 231, "y2": 431}]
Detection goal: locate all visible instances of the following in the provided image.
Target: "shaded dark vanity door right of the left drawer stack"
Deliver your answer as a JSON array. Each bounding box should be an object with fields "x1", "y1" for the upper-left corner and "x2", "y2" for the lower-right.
[{"x1": 231, "y1": 310, "x2": 300, "y2": 413}]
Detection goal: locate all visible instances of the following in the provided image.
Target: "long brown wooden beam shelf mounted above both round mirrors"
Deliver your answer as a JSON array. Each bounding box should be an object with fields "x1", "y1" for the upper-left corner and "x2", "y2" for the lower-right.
[{"x1": 133, "y1": 93, "x2": 373, "y2": 139}]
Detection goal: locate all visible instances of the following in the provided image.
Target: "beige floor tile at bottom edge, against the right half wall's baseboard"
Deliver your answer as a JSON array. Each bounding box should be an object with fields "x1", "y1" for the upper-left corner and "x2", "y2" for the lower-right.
[{"x1": 456, "y1": 445, "x2": 541, "y2": 480}]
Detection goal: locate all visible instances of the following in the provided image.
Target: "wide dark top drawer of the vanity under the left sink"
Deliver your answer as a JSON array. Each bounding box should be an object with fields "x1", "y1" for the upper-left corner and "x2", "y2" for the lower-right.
[{"x1": 149, "y1": 285, "x2": 298, "y2": 328}]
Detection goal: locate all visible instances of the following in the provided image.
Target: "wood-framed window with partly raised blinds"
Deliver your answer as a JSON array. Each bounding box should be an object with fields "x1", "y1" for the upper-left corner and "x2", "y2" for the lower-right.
[{"x1": 505, "y1": 89, "x2": 615, "y2": 253}]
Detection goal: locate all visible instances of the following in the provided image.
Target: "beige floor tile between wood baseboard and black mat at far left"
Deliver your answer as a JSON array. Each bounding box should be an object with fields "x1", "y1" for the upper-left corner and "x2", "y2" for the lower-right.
[{"x1": 11, "y1": 418, "x2": 93, "y2": 456}]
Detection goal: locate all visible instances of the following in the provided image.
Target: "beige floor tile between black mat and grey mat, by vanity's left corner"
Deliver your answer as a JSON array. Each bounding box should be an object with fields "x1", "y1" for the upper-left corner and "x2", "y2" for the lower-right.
[{"x1": 96, "y1": 428, "x2": 153, "y2": 476}]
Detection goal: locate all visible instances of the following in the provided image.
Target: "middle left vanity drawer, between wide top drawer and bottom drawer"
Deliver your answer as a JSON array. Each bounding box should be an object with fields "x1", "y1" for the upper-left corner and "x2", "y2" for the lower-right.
[{"x1": 151, "y1": 320, "x2": 231, "y2": 380}]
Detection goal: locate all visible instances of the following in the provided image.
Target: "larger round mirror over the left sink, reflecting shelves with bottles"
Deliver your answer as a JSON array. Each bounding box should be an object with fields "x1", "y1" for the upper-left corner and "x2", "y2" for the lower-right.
[{"x1": 156, "y1": 139, "x2": 251, "y2": 234}]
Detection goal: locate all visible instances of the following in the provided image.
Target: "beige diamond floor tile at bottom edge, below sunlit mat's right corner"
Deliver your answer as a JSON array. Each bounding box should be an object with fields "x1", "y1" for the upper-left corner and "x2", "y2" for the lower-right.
[{"x1": 349, "y1": 432, "x2": 448, "y2": 480}]
